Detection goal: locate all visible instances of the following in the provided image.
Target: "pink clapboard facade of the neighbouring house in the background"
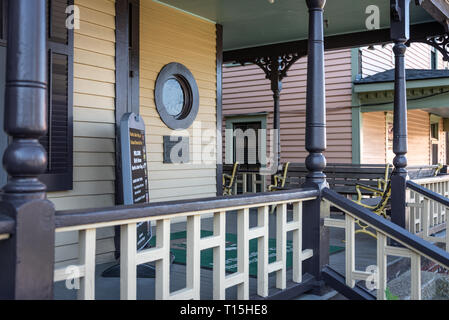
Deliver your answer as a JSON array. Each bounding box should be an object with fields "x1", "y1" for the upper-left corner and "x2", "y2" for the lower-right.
[{"x1": 223, "y1": 43, "x2": 449, "y2": 165}]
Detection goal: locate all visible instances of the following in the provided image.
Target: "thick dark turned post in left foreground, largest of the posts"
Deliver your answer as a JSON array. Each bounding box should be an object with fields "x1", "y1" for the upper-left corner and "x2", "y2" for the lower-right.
[{"x1": 0, "y1": 0, "x2": 55, "y2": 299}]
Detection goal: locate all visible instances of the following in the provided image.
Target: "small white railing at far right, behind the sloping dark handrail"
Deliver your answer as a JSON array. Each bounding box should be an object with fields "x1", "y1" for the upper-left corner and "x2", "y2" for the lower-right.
[{"x1": 407, "y1": 175, "x2": 449, "y2": 246}]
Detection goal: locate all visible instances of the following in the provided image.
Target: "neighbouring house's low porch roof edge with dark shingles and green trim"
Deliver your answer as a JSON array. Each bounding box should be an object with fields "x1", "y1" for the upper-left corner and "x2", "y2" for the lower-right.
[{"x1": 354, "y1": 70, "x2": 449, "y2": 118}]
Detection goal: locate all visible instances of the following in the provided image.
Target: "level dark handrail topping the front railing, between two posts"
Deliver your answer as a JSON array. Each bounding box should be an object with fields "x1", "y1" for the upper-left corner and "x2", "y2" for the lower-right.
[{"x1": 55, "y1": 188, "x2": 319, "y2": 229}]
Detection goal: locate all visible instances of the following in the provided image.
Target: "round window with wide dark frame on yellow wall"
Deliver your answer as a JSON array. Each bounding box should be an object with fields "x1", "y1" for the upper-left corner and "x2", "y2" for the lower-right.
[{"x1": 154, "y1": 63, "x2": 199, "y2": 130}]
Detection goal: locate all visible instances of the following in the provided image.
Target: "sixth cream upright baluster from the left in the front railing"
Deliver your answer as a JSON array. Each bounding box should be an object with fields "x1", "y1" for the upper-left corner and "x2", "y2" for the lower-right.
[{"x1": 237, "y1": 208, "x2": 249, "y2": 300}]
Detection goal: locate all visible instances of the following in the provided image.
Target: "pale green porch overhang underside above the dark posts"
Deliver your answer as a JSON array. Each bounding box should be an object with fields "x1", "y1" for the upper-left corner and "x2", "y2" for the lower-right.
[{"x1": 153, "y1": 0, "x2": 449, "y2": 62}]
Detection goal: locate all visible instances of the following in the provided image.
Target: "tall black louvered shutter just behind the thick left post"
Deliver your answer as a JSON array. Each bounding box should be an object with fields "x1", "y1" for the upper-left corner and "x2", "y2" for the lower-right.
[{"x1": 39, "y1": 0, "x2": 73, "y2": 191}]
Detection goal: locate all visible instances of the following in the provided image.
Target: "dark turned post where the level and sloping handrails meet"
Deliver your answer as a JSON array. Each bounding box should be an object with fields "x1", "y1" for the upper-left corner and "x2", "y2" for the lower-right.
[{"x1": 303, "y1": 0, "x2": 329, "y2": 289}]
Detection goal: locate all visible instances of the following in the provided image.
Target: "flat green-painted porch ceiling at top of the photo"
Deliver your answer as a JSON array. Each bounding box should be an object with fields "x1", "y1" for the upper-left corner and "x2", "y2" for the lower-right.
[{"x1": 153, "y1": 0, "x2": 435, "y2": 51}]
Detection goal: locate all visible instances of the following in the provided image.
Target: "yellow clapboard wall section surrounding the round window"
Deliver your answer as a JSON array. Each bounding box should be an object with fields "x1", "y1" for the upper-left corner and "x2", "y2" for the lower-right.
[{"x1": 140, "y1": 0, "x2": 216, "y2": 202}]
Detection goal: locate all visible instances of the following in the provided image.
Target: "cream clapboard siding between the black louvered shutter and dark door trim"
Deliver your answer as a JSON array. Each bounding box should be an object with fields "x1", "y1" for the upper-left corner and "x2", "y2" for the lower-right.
[{"x1": 48, "y1": 0, "x2": 115, "y2": 266}]
